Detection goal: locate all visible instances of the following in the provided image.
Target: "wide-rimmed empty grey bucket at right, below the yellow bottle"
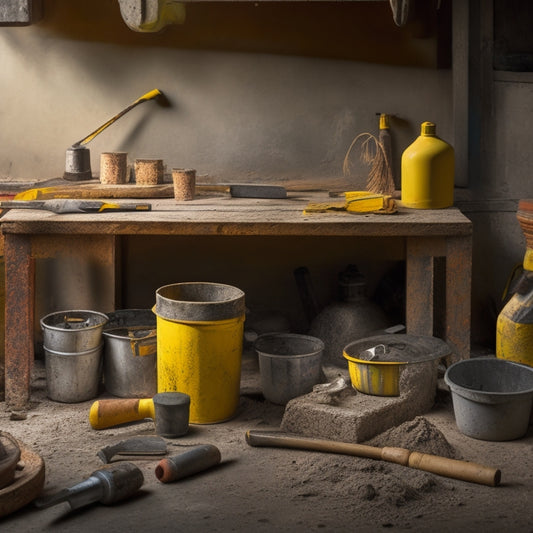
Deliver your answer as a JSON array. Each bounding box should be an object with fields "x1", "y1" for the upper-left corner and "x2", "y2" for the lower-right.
[{"x1": 444, "y1": 357, "x2": 533, "y2": 441}]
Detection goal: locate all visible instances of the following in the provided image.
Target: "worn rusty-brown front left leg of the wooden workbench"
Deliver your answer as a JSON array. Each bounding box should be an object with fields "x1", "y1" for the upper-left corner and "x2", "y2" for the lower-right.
[{"x1": 4, "y1": 234, "x2": 35, "y2": 411}]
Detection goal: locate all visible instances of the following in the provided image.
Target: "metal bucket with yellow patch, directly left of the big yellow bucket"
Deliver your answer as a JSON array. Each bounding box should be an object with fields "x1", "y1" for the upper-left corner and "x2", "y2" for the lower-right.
[{"x1": 103, "y1": 309, "x2": 157, "y2": 398}]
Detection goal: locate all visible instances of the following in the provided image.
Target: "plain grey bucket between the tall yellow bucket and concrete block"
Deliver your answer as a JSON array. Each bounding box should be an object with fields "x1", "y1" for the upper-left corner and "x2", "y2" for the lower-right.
[{"x1": 254, "y1": 333, "x2": 324, "y2": 405}]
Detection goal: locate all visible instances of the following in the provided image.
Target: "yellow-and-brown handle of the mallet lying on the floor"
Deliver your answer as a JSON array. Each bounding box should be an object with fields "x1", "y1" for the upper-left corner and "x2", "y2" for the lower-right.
[{"x1": 89, "y1": 398, "x2": 155, "y2": 429}]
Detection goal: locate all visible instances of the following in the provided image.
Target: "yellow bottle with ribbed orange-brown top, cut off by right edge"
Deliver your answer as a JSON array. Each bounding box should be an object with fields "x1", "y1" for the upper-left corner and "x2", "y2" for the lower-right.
[{"x1": 496, "y1": 200, "x2": 533, "y2": 366}]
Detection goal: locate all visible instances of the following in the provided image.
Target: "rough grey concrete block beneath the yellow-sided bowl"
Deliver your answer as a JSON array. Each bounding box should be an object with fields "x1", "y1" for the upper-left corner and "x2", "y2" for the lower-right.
[{"x1": 281, "y1": 361, "x2": 438, "y2": 443}]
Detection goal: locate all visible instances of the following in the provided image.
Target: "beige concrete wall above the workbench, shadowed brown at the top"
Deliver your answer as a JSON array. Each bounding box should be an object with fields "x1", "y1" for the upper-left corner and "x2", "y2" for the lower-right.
[{"x1": 0, "y1": 0, "x2": 452, "y2": 181}]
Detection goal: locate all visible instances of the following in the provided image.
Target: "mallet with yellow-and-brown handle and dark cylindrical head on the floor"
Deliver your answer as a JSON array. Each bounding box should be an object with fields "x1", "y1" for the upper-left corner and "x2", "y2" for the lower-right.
[{"x1": 89, "y1": 392, "x2": 191, "y2": 438}]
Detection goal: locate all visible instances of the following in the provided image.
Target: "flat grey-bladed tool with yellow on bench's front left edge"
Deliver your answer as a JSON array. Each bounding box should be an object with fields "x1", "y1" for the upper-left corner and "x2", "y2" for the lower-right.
[{"x1": 0, "y1": 199, "x2": 152, "y2": 214}]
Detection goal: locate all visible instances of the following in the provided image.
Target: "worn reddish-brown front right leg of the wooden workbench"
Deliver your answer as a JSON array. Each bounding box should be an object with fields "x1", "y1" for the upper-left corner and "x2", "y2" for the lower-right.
[{"x1": 445, "y1": 236, "x2": 472, "y2": 361}]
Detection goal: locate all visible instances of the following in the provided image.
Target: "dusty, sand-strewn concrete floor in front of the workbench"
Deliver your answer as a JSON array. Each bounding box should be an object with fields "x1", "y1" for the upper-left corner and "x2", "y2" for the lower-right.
[{"x1": 0, "y1": 350, "x2": 533, "y2": 533}]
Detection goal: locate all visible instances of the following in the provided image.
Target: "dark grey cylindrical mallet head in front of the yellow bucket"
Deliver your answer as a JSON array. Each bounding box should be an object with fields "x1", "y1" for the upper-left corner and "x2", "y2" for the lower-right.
[{"x1": 153, "y1": 392, "x2": 191, "y2": 438}]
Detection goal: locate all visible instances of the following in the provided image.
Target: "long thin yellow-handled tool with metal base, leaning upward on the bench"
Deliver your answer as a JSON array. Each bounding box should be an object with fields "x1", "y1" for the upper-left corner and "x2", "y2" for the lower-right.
[{"x1": 63, "y1": 89, "x2": 164, "y2": 181}]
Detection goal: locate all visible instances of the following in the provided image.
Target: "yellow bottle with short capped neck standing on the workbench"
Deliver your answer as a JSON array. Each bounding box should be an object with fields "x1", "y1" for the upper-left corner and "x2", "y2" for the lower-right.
[{"x1": 401, "y1": 122, "x2": 455, "y2": 209}]
